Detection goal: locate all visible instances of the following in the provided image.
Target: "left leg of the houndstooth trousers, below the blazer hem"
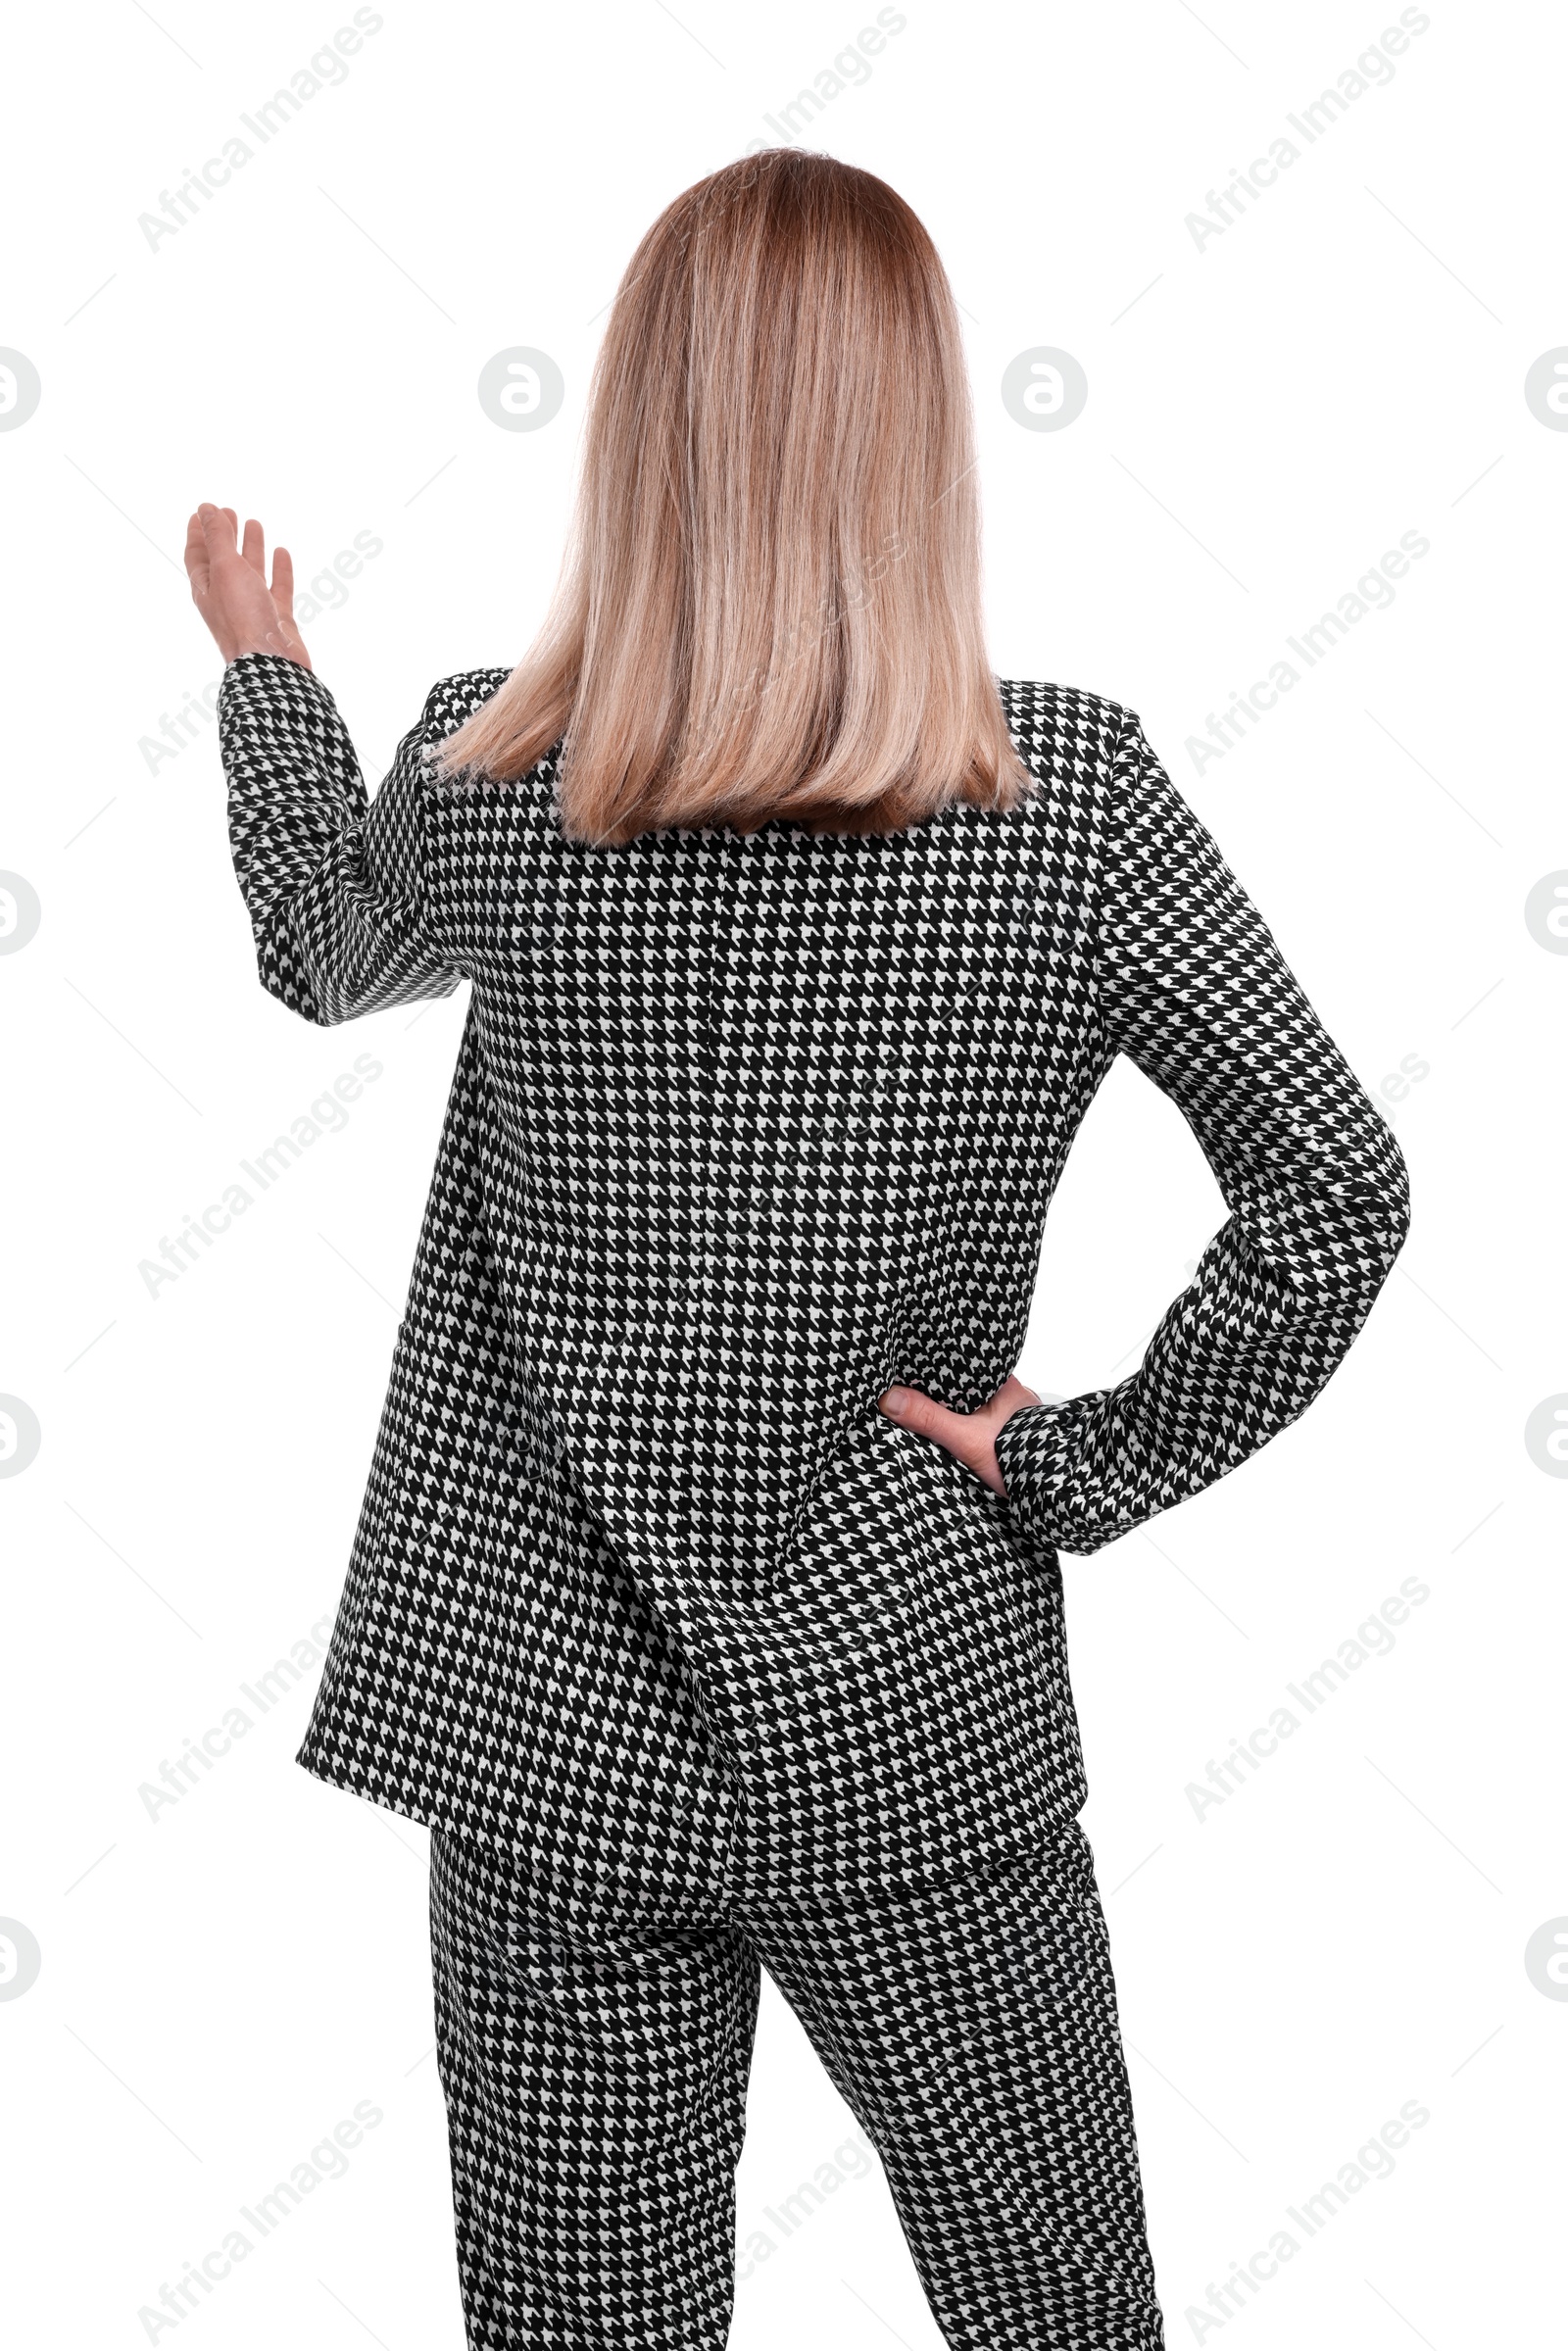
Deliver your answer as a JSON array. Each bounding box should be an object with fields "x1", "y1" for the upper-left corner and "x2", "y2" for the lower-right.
[{"x1": 430, "y1": 1834, "x2": 760, "y2": 2351}]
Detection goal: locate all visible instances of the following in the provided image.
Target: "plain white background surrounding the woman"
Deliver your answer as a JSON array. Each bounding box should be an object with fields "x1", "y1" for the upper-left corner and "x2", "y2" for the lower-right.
[{"x1": 0, "y1": 0, "x2": 1568, "y2": 2351}]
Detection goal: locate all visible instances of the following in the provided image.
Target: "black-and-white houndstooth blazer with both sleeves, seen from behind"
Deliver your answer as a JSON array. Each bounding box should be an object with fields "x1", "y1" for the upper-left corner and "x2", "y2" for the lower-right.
[{"x1": 219, "y1": 654, "x2": 1410, "y2": 1895}]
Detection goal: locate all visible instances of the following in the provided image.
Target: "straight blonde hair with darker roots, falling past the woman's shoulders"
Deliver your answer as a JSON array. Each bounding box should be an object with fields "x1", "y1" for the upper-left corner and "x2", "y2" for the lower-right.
[{"x1": 440, "y1": 148, "x2": 1025, "y2": 844}]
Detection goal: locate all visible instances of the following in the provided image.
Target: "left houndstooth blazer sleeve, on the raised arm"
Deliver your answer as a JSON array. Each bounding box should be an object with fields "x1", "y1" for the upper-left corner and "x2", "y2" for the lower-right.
[{"x1": 219, "y1": 654, "x2": 464, "y2": 1027}]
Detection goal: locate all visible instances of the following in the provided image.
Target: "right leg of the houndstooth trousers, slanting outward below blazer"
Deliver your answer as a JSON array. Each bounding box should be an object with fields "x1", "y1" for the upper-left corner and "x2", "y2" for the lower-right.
[{"x1": 748, "y1": 1822, "x2": 1163, "y2": 2351}]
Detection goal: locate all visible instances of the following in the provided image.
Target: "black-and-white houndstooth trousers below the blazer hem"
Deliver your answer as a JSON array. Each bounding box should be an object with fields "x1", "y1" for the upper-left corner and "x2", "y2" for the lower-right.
[{"x1": 430, "y1": 1822, "x2": 1163, "y2": 2351}]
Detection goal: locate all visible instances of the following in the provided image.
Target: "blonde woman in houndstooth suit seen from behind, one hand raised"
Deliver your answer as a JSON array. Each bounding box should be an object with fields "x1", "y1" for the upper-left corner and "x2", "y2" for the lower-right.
[{"x1": 188, "y1": 148, "x2": 1408, "y2": 2351}]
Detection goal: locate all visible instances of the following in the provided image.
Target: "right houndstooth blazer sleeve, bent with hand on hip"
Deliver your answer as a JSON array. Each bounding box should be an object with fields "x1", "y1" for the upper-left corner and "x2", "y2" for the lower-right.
[{"x1": 997, "y1": 712, "x2": 1410, "y2": 1551}]
